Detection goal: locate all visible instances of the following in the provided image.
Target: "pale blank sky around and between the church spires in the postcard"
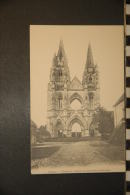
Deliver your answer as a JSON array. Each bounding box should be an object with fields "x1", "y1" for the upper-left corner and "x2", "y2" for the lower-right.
[{"x1": 30, "y1": 25, "x2": 124, "y2": 126}]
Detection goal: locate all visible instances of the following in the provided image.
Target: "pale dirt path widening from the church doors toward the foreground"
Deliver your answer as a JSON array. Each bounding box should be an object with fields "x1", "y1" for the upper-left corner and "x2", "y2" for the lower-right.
[{"x1": 41, "y1": 142, "x2": 109, "y2": 166}]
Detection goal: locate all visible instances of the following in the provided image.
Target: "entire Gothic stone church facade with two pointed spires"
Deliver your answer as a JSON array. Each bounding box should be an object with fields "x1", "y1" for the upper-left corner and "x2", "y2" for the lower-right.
[{"x1": 47, "y1": 41, "x2": 100, "y2": 137}]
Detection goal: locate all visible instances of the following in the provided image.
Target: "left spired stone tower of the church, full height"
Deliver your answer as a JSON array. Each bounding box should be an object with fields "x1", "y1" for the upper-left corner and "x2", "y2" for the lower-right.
[{"x1": 48, "y1": 40, "x2": 70, "y2": 136}]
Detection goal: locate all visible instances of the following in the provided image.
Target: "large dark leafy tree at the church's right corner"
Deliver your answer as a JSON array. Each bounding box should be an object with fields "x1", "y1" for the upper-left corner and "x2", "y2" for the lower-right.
[{"x1": 90, "y1": 107, "x2": 114, "y2": 138}]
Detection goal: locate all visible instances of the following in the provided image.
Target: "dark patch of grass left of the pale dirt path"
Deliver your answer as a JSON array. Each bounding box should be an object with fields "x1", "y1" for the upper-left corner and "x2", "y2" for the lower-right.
[{"x1": 31, "y1": 146, "x2": 60, "y2": 160}]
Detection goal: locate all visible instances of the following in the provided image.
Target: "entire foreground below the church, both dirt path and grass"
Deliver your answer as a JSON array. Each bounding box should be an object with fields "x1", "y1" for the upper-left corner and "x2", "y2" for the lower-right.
[{"x1": 31, "y1": 140, "x2": 125, "y2": 174}]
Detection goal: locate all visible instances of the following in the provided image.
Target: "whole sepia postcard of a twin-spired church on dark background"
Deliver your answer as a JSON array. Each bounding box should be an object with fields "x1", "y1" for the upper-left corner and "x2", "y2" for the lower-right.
[{"x1": 30, "y1": 25, "x2": 125, "y2": 174}]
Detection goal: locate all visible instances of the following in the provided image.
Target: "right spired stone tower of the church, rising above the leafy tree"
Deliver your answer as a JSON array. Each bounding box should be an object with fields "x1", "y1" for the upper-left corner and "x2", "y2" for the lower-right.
[{"x1": 82, "y1": 44, "x2": 100, "y2": 113}]
